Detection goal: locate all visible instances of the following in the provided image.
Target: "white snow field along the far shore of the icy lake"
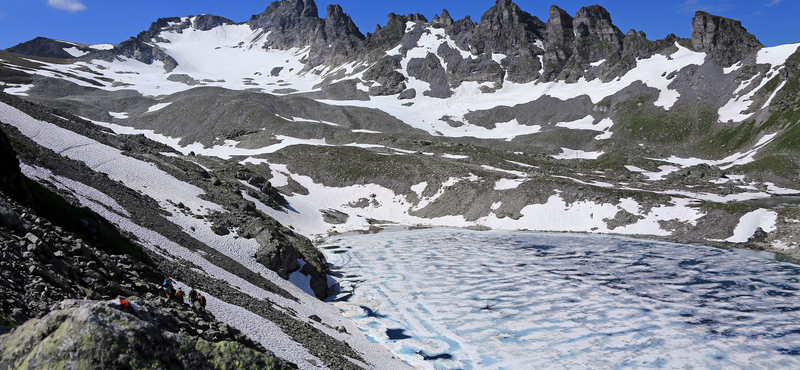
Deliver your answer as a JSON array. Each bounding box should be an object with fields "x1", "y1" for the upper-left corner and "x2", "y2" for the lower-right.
[{"x1": 231, "y1": 157, "x2": 703, "y2": 236}]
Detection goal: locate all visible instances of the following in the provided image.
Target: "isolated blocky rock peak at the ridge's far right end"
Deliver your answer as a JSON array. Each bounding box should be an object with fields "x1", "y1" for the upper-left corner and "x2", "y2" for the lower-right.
[{"x1": 692, "y1": 11, "x2": 764, "y2": 67}]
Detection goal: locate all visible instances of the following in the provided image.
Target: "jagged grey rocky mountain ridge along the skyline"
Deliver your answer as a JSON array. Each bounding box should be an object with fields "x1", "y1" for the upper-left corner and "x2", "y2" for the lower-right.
[{"x1": 6, "y1": 0, "x2": 763, "y2": 86}]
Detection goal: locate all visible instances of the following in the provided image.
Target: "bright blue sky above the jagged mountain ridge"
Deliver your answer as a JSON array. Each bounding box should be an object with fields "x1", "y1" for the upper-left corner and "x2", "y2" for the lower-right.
[{"x1": 0, "y1": 0, "x2": 800, "y2": 49}]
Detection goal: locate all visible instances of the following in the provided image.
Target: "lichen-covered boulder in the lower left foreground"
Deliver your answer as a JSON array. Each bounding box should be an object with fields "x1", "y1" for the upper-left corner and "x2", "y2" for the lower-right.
[{"x1": 0, "y1": 300, "x2": 291, "y2": 369}]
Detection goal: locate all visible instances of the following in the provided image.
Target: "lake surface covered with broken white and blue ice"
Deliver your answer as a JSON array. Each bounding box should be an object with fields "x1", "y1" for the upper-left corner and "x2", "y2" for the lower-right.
[{"x1": 321, "y1": 228, "x2": 800, "y2": 369}]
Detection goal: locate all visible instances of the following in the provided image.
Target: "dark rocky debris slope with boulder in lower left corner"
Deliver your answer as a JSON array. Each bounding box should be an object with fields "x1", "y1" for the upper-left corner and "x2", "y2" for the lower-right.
[{"x1": 0, "y1": 161, "x2": 296, "y2": 369}]
